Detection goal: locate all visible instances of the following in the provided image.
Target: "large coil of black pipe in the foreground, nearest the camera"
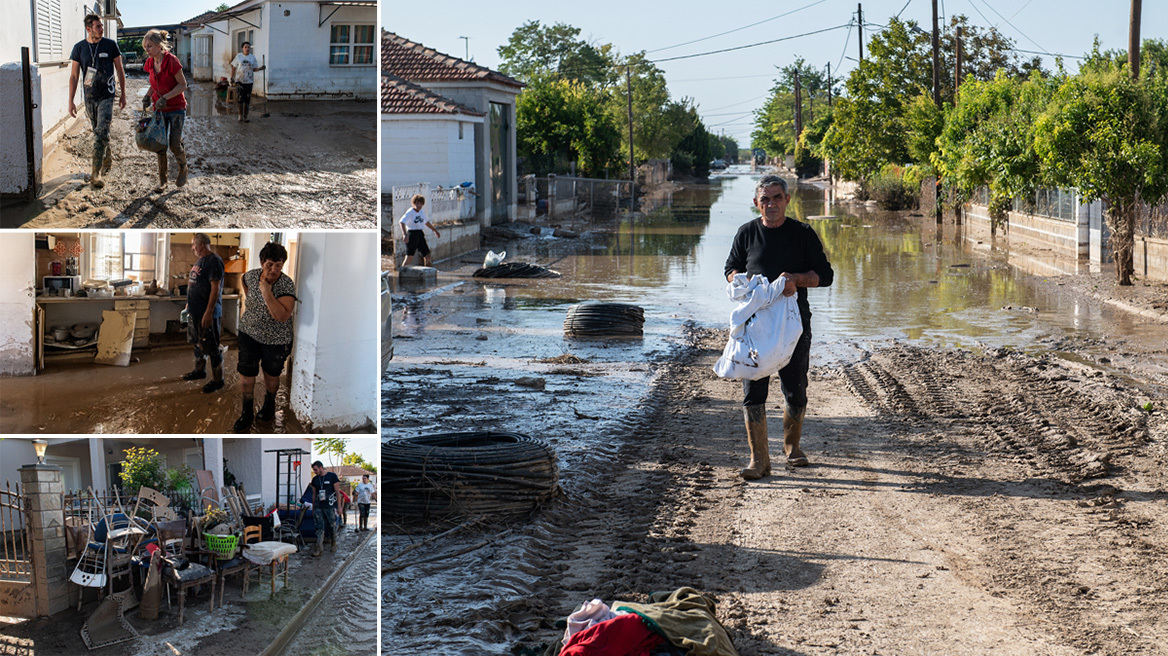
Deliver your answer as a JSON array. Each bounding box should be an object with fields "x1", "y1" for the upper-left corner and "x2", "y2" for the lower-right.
[{"x1": 380, "y1": 431, "x2": 559, "y2": 521}]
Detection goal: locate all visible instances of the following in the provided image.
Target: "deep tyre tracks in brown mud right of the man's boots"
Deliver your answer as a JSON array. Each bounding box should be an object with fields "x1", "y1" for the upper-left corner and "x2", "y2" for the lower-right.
[{"x1": 843, "y1": 344, "x2": 1143, "y2": 483}]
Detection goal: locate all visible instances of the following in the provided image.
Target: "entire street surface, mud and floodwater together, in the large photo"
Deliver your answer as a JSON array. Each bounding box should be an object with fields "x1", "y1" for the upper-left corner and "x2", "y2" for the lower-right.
[{"x1": 382, "y1": 175, "x2": 1168, "y2": 656}]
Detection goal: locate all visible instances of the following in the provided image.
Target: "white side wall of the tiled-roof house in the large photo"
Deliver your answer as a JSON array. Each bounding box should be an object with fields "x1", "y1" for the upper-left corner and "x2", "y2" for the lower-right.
[{"x1": 381, "y1": 114, "x2": 482, "y2": 193}]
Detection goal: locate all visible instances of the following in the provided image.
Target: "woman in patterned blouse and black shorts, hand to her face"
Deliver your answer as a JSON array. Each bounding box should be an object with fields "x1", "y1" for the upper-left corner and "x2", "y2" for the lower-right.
[{"x1": 232, "y1": 243, "x2": 297, "y2": 433}]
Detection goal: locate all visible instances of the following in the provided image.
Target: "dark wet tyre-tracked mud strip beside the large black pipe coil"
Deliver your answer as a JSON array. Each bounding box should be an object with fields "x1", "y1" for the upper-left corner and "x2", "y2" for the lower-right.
[{"x1": 382, "y1": 327, "x2": 712, "y2": 656}]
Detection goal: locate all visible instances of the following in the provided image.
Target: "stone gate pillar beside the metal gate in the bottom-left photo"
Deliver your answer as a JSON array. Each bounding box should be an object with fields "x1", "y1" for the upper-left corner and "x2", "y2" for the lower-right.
[{"x1": 20, "y1": 465, "x2": 69, "y2": 616}]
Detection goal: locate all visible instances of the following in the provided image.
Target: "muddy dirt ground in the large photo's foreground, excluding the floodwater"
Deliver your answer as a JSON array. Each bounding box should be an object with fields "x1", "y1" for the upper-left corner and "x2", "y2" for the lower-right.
[{"x1": 382, "y1": 193, "x2": 1168, "y2": 656}]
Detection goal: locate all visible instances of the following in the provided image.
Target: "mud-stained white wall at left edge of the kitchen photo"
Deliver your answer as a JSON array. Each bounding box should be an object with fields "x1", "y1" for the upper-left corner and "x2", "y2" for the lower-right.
[{"x1": 0, "y1": 231, "x2": 36, "y2": 376}]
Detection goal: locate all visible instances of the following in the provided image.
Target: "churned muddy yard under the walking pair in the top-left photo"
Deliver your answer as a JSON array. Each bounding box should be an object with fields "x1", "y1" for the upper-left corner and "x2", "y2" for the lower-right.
[{"x1": 2, "y1": 76, "x2": 377, "y2": 230}]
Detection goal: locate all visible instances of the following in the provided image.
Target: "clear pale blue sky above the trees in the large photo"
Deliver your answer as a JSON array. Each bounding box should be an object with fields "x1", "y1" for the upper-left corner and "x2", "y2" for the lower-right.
[{"x1": 385, "y1": 0, "x2": 1168, "y2": 146}]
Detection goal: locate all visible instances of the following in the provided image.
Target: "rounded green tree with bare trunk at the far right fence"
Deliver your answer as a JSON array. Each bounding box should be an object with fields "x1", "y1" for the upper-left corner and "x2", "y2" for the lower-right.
[{"x1": 1035, "y1": 70, "x2": 1168, "y2": 285}]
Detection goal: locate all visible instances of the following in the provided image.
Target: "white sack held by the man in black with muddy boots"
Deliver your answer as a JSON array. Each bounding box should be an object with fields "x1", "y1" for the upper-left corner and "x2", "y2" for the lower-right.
[{"x1": 714, "y1": 273, "x2": 802, "y2": 381}]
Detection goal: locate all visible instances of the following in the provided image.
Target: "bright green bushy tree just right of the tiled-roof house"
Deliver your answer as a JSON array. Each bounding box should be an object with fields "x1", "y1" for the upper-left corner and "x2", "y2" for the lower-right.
[{"x1": 515, "y1": 75, "x2": 620, "y2": 176}]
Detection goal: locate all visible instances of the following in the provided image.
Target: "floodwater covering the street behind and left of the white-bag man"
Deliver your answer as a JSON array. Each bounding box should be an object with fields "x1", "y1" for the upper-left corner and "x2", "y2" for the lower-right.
[{"x1": 382, "y1": 165, "x2": 1168, "y2": 655}]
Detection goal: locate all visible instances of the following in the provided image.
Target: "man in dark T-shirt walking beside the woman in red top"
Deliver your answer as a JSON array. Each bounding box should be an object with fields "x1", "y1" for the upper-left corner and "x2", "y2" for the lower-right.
[{"x1": 69, "y1": 14, "x2": 126, "y2": 189}]
